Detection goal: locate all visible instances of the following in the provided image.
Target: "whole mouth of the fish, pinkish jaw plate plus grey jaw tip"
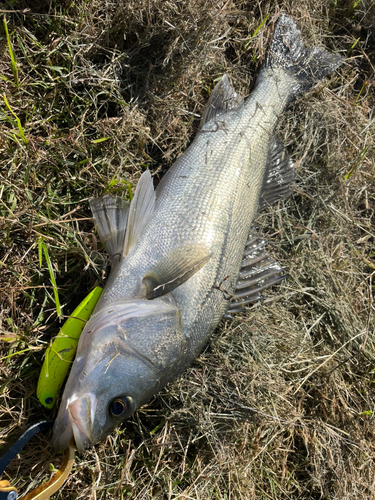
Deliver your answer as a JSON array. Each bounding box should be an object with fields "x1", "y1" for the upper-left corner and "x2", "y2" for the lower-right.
[{"x1": 54, "y1": 393, "x2": 97, "y2": 452}]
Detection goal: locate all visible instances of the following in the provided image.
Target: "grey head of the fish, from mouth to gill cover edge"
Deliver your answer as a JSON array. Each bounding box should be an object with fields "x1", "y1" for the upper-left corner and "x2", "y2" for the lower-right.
[{"x1": 52, "y1": 297, "x2": 186, "y2": 451}]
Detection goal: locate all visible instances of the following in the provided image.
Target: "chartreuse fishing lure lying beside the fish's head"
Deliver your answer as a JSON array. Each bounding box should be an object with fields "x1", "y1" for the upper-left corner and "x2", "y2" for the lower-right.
[{"x1": 36, "y1": 286, "x2": 103, "y2": 409}]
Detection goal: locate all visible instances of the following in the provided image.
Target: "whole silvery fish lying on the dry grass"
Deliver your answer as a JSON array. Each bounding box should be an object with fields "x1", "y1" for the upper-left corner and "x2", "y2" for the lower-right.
[{"x1": 52, "y1": 14, "x2": 343, "y2": 451}]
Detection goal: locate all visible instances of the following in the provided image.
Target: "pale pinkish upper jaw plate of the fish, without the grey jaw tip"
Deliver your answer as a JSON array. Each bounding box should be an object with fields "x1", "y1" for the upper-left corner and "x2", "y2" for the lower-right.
[{"x1": 67, "y1": 393, "x2": 98, "y2": 452}]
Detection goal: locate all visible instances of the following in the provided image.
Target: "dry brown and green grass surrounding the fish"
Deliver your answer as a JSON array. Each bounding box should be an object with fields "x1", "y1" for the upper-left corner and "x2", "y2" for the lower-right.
[{"x1": 0, "y1": 0, "x2": 375, "y2": 500}]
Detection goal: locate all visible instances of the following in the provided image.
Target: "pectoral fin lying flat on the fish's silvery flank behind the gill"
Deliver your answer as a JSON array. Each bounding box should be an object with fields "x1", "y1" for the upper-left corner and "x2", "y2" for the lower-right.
[{"x1": 142, "y1": 243, "x2": 211, "y2": 300}]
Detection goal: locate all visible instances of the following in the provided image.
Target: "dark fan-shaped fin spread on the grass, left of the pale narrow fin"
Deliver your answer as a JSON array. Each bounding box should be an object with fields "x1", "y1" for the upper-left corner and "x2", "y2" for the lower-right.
[{"x1": 90, "y1": 194, "x2": 130, "y2": 257}]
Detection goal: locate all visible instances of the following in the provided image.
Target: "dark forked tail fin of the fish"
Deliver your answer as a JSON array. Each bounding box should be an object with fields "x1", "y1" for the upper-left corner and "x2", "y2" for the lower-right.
[{"x1": 264, "y1": 14, "x2": 344, "y2": 95}]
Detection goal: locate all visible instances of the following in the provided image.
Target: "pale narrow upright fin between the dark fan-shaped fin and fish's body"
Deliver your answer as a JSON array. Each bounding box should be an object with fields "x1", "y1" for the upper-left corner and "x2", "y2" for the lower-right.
[{"x1": 124, "y1": 170, "x2": 155, "y2": 255}]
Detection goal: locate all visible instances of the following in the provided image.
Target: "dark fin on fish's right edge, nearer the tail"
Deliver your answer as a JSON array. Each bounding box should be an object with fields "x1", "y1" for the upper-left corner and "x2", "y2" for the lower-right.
[{"x1": 259, "y1": 137, "x2": 295, "y2": 209}]
